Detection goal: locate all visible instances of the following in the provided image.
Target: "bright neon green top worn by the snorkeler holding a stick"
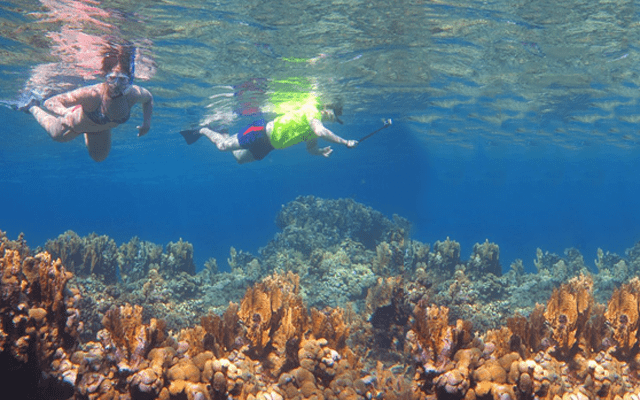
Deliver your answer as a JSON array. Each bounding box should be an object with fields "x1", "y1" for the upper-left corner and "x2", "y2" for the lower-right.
[{"x1": 271, "y1": 100, "x2": 322, "y2": 149}]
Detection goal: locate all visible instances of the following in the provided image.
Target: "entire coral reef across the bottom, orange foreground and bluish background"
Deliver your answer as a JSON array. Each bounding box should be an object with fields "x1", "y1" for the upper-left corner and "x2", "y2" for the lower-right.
[{"x1": 6, "y1": 197, "x2": 640, "y2": 400}]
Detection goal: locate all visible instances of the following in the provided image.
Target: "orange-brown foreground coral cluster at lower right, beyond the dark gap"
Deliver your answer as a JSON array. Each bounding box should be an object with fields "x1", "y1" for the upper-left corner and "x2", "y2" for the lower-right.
[{"x1": 407, "y1": 276, "x2": 640, "y2": 400}]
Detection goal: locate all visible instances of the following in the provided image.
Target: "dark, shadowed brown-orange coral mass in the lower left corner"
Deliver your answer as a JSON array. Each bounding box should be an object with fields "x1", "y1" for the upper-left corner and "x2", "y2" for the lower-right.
[{"x1": 0, "y1": 231, "x2": 82, "y2": 399}]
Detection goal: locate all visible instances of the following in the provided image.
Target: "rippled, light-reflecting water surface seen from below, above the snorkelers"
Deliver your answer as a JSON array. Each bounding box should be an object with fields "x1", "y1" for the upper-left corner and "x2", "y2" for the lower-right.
[{"x1": 0, "y1": 0, "x2": 640, "y2": 147}]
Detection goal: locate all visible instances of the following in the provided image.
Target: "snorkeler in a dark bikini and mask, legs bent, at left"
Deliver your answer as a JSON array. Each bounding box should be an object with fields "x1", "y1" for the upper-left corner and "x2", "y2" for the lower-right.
[{"x1": 18, "y1": 46, "x2": 153, "y2": 162}]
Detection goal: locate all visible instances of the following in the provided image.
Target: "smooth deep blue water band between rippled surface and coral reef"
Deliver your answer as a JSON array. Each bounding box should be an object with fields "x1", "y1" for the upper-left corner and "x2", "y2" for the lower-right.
[{"x1": 5, "y1": 101, "x2": 640, "y2": 270}]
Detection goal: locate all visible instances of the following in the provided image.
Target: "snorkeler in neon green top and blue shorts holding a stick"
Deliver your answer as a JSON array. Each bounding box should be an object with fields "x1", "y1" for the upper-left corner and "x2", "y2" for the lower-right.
[{"x1": 180, "y1": 94, "x2": 358, "y2": 164}]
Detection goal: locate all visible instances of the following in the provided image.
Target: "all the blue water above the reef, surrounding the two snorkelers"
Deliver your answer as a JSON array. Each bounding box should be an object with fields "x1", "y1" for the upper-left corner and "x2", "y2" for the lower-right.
[{"x1": 0, "y1": 1, "x2": 640, "y2": 271}]
